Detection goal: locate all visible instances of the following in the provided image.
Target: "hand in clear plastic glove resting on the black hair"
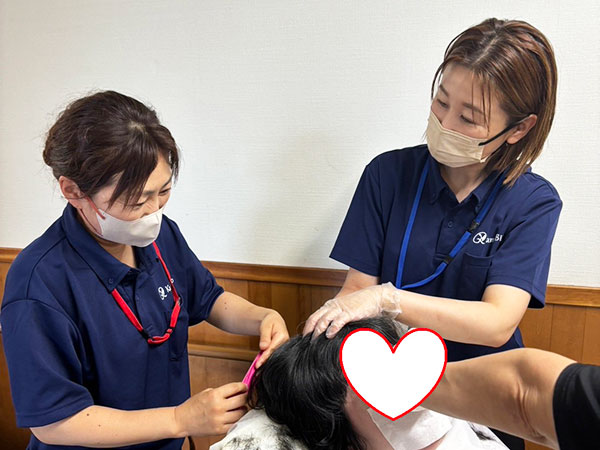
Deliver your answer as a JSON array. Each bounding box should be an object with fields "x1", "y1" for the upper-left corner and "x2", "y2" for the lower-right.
[{"x1": 302, "y1": 282, "x2": 402, "y2": 338}]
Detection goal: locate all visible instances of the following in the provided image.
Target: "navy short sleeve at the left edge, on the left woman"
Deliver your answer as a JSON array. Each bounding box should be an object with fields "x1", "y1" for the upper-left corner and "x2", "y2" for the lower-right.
[{"x1": 0, "y1": 300, "x2": 94, "y2": 427}]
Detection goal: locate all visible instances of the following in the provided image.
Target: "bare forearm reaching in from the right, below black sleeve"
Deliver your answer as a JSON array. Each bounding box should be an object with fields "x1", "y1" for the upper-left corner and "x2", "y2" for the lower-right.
[{"x1": 423, "y1": 348, "x2": 575, "y2": 448}]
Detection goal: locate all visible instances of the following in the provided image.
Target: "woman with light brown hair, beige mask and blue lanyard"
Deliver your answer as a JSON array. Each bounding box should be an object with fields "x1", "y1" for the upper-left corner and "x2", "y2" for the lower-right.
[{"x1": 304, "y1": 19, "x2": 562, "y2": 448}]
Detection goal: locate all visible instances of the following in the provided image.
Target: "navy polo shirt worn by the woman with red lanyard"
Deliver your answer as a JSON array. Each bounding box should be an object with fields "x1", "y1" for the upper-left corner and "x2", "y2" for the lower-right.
[{"x1": 0, "y1": 205, "x2": 223, "y2": 449}]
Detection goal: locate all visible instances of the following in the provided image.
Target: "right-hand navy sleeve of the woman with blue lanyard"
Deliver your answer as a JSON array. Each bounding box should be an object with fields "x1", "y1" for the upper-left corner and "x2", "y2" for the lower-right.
[{"x1": 487, "y1": 183, "x2": 562, "y2": 308}]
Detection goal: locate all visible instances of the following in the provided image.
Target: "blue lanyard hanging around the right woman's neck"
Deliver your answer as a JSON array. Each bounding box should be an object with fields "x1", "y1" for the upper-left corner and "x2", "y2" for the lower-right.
[{"x1": 396, "y1": 161, "x2": 504, "y2": 289}]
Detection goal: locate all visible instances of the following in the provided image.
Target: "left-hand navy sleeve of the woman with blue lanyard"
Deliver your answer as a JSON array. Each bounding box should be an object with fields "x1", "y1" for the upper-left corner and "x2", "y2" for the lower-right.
[{"x1": 330, "y1": 160, "x2": 384, "y2": 277}]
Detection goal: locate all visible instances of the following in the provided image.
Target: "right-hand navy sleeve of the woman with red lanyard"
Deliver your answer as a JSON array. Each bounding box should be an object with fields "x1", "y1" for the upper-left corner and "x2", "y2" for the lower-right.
[{"x1": 164, "y1": 220, "x2": 224, "y2": 326}]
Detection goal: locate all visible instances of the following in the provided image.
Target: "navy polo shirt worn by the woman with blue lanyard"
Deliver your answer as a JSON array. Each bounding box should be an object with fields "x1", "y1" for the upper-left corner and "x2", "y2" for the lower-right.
[{"x1": 331, "y1": 145, "x2": 562, "y2": 361}]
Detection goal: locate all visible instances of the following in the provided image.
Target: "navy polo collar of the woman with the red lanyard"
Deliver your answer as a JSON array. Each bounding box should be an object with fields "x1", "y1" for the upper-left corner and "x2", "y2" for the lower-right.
[{"x1": 61, "y1": 204, "x2": 156, "y2": 292}]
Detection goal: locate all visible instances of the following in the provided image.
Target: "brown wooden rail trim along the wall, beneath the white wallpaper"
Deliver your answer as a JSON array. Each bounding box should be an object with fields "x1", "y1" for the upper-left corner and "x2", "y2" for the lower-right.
[{"x1": 0, "y1": 247, "x2": 600, "y2": 308}]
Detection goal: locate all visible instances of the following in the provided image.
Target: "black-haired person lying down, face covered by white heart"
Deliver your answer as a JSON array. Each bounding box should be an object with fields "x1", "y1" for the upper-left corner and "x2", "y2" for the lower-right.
[{"x1": 211, "y1": 317, "x2": 506, "y2": 450}]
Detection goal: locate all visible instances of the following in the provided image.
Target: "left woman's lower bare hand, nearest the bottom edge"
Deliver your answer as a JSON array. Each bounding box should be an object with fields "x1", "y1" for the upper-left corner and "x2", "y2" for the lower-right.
[{"x1": 175, "y1": 383, "x2": 248, "y2": 436}]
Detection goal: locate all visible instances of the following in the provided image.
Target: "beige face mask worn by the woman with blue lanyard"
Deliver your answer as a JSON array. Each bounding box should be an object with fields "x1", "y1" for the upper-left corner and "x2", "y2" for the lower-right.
[{"x1": 426, "y1": 111, "x2": 518, "y2": 167}]
